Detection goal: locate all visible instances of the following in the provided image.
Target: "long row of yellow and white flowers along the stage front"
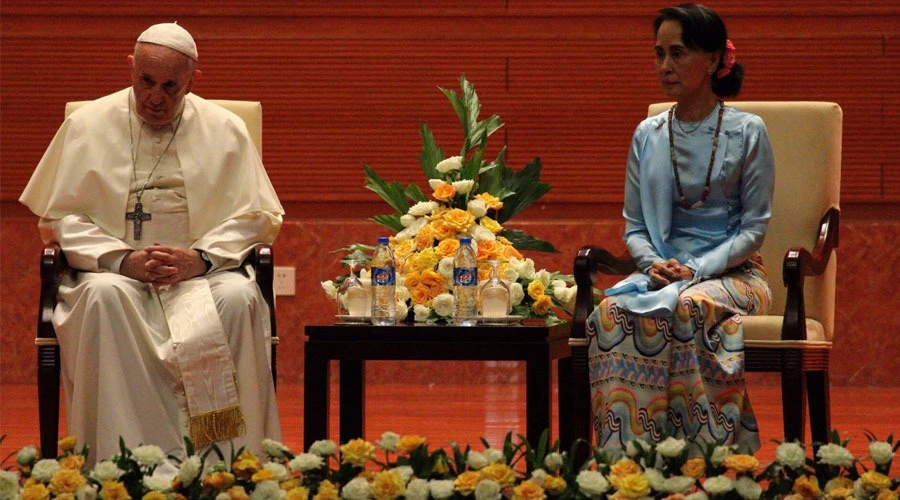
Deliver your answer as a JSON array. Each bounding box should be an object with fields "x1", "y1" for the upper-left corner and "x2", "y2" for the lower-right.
[{"x1": 0, "y1": 432, "x2": 900, "y2": 500}]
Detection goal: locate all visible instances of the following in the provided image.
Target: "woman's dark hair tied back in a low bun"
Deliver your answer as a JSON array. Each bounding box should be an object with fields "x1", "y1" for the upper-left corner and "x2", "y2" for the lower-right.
[{"x1": 653, "y1": 3, "x2": 744, "y2": 97}]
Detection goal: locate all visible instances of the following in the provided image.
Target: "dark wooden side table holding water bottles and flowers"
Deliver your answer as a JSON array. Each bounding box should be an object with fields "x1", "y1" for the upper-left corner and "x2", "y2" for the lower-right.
[{"x1": 303, "y1": 323, "x2": 570, "y2": 449}]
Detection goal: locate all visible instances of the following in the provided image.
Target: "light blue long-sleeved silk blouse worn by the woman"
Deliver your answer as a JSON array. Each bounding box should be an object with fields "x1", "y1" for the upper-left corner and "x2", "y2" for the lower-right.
[{"x1": 605, "y1": 106, "x2": 775, "y2": 315}]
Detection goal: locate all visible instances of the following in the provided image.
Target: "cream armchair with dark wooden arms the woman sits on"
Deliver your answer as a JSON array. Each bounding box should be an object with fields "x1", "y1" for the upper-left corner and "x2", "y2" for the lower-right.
[{"x1": 560, "y1": 102, "x2": 843, "y2": 458}]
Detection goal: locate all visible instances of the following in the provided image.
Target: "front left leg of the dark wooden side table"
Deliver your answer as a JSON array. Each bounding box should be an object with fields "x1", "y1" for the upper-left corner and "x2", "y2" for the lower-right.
[{"x1": 303, "y1": 342, "x2": 329, "y2": 450}]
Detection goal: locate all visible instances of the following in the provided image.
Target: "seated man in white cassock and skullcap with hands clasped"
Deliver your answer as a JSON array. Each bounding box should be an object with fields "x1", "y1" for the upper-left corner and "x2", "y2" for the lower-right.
[{"x1": 20, "y1": 23, "x2": 284, "y2": 462}]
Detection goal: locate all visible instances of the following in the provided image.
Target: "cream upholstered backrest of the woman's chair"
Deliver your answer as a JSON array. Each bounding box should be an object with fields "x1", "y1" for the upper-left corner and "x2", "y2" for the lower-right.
[{"x1": 648, "y1": 101, "x2": 843, "y2": 340}]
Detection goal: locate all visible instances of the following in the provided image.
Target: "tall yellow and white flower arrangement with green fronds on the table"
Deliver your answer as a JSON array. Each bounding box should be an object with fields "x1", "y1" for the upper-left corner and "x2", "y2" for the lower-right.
[{"x1": 322, "y1": 76, "x2": 576, "y2": 324}]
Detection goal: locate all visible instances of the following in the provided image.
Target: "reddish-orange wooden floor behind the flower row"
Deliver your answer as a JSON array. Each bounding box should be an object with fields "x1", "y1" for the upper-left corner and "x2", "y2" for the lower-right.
[{"x1": 0, "y1": 380, "x2": 900, "y2": 477}]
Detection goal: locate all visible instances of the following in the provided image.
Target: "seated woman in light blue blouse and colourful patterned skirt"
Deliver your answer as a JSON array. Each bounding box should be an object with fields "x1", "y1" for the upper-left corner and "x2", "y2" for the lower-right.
[{"x1": 588, "y1": 4, "x2": 775, "y2": 451}]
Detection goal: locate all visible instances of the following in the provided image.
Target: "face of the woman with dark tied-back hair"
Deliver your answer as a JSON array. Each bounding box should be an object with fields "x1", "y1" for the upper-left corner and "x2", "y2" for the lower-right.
[{"x1": 654, "y1": 20, "x2": 718, "y2": 102}]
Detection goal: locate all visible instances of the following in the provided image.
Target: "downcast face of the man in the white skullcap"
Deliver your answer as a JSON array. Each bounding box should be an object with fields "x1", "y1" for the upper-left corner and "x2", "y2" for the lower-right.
[{"x1": 128, "y1": 43, "x2": 199, "y2": 126}]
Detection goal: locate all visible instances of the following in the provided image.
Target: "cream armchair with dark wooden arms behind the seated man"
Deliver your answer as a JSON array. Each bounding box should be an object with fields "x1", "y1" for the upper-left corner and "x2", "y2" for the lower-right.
[{"x1": 35, "y1": 99, "x2": 278, "y2": 456}]
